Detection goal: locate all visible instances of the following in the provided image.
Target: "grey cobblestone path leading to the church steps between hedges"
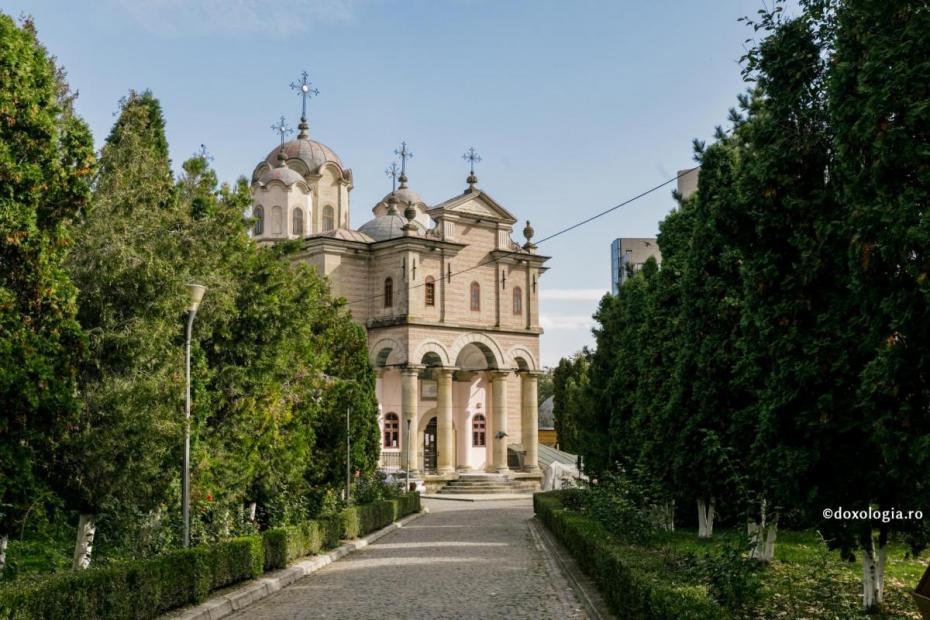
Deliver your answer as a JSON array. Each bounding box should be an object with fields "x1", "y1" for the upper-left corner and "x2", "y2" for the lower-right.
[{"x1": 232, "y1": 500, "x2": 588, "y2": 620}]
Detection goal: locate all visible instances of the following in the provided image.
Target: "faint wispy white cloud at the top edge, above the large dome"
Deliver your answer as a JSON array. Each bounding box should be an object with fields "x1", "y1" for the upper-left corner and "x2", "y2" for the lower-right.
[{"x1": 113, "y1": 0, "x2": 357, "y2": 36}]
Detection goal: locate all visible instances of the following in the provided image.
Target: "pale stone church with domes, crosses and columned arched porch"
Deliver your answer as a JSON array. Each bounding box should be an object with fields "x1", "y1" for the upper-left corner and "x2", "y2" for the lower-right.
[{"x1": 252, "y1": 114, "x2": 547, "y2": 485}]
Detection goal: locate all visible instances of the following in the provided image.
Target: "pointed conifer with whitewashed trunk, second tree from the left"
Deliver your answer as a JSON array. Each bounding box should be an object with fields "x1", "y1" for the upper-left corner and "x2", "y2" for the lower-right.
[{"x1": 62, "y1": 92, "x2": 187, "y2": 567}]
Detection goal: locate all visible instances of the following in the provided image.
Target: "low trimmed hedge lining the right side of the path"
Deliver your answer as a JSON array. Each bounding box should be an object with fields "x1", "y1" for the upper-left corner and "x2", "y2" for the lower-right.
[{"x1": 533, "y1": 491, "x2": 730, "y2": 620}]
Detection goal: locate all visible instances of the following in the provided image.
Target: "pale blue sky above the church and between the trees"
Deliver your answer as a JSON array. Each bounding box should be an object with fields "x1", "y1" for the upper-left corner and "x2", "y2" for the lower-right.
[{"x1": 3, "y1": 0, "x2": 792, "y2": 364}]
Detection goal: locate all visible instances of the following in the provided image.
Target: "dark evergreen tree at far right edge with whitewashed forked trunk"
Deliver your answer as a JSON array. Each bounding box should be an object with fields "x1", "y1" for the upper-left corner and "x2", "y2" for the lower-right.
[{"x1": 824, "y1": 0, "x2": 930, "y2": 608}]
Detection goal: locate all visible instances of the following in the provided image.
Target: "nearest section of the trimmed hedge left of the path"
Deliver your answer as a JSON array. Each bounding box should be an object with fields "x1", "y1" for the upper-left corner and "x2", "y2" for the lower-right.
[{"x1": 0, "y1": 536, "x2": 264, "y2": 620}]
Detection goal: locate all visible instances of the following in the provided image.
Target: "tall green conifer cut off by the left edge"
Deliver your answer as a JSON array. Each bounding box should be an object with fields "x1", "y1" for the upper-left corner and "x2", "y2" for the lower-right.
[{"x1": 0, "y1": 14, "x2": 95, "y2": 571}]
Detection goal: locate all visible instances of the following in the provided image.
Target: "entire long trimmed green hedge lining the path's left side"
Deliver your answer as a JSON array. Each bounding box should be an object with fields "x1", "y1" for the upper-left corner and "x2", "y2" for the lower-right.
[{"x1": 0, "y1": 493, "x2": 420, "y2": 620}]
